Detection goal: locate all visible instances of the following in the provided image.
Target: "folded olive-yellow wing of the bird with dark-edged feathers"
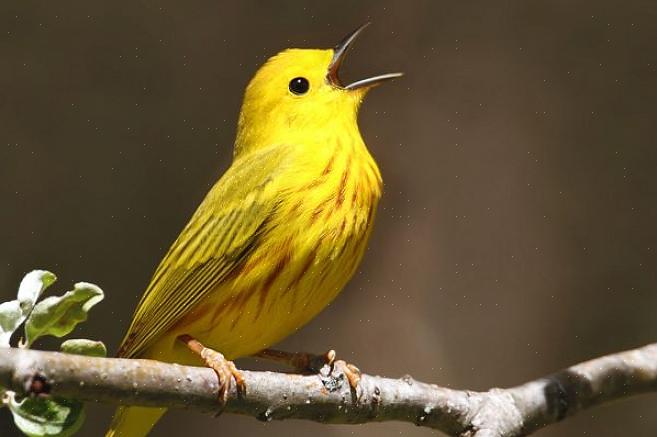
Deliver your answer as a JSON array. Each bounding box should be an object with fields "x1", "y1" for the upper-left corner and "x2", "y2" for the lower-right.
[{"x1": 118, "y1": 146, "x2": 288, "y2": 357}]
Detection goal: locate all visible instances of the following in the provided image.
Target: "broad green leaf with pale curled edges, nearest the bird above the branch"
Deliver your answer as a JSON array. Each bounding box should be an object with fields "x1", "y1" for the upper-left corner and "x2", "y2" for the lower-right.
[{"x1": 25, "y1": 282, "x2": 104, "y2": 346}]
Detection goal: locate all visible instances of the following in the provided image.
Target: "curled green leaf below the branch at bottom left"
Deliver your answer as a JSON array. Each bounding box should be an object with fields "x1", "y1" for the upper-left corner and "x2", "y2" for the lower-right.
[{"x1": 8, "y1": 395, "x2": 84, "y2": 437}]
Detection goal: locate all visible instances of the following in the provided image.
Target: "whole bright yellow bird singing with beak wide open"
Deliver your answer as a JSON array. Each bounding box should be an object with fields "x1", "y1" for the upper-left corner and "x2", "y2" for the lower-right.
[{"x1": 107, "y1": 25, "x2": 401, "y2": 437}]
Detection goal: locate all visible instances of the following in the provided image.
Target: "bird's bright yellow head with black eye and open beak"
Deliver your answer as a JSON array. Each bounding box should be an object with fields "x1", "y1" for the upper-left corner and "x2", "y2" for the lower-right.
[{"x1": 235, "y1": 24, "x2": 402, "y2": 156}]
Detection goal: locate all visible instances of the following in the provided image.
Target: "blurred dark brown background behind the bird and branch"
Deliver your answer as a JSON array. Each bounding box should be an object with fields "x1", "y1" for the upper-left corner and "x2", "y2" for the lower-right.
[{"x1": 0, "y1": 0, "x2": 657, "y2": 437}]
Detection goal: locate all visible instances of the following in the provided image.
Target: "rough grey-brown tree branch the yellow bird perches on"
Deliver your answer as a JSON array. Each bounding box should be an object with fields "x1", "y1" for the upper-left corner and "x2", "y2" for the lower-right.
[{"x1": 0, "y1": 343, "x2": 657, "y2": 437}]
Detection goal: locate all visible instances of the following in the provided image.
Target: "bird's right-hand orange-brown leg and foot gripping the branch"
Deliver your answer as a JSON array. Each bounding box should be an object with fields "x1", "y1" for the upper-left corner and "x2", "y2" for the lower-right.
[{"x1": 254, "y1": 349, "x2": 360, "y2": 390}]
